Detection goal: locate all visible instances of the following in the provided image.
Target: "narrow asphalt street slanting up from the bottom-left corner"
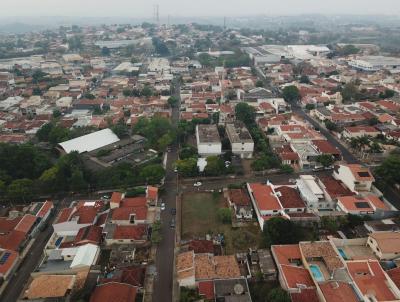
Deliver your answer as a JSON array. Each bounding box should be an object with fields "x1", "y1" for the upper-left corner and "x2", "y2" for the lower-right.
[{"x1": 0, "y1": 200, "x2": 66, "y2": 302}]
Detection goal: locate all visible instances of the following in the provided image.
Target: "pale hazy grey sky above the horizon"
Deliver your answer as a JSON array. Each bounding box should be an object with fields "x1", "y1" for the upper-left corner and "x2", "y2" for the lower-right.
[{"x1": 0, "y1": 0, "x2": 400, "y2": 18}]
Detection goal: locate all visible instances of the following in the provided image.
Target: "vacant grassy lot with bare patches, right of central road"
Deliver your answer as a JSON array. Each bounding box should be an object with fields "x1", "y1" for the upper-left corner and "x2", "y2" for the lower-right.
[{"x1": 182, "y1": 193, "x2": 261, "y2": 254}]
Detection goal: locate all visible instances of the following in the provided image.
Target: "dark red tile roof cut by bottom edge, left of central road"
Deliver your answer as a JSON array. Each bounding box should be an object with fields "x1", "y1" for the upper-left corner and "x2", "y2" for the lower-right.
[{"x1": 90, "y1": 282, "x2": 137, "y2": 302}]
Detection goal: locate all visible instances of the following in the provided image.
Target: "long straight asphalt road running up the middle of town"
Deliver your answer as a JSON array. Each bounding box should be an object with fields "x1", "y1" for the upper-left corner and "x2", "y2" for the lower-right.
[{"x1": 153, "y1": 78, "x2": 180, "y2": 302}]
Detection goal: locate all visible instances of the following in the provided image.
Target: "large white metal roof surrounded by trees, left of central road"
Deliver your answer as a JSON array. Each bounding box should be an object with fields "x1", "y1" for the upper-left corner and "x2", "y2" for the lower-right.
[{"x1": 60, "y1": 128, "x2": 119, "y2": 153}]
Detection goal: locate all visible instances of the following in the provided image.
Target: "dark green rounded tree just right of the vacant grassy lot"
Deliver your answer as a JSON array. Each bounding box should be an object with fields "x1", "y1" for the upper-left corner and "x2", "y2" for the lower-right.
[{"x1": 263, "y1": 217, "x2": 298, "y2": 247}]
